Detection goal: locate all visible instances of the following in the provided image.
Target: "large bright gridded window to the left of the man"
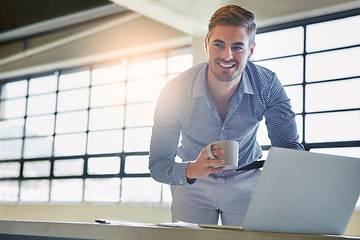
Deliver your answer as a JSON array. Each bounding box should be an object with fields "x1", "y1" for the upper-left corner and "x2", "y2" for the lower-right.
[{"x1": 0, "y1": 47, "x2": 192, "y2": 203}]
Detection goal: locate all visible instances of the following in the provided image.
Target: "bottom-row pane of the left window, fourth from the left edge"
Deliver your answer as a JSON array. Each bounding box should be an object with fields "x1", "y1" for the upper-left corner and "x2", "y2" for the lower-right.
[{"x1": 84, "y1": 178, "x2": 119, "y2": 202}]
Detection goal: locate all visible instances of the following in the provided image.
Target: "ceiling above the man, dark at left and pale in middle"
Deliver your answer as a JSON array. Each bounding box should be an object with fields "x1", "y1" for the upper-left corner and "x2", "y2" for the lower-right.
[{"x1": 0, "y1": 0, "x2": 360, "y2": 42}]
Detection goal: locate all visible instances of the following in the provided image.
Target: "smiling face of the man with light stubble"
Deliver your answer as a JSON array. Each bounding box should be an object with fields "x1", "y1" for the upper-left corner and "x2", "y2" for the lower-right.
[{"x1": 205, "y1": 25, "x2": 255, "y2": 82}]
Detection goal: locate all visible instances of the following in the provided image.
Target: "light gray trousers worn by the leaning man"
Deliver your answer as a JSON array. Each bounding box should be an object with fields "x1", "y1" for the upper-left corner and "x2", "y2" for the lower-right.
[{"x1": 171, "y1": 169, "x2": 261, "y2": 226}]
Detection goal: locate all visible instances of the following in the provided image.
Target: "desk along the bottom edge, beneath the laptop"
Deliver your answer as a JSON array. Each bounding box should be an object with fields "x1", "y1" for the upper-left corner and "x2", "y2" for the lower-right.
[{"x1": 0, "y1": 220, "x2": 360, "y2": 240}]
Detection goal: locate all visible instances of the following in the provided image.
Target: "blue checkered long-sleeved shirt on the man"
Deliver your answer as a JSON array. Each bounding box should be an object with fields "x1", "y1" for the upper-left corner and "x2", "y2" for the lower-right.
[{"x1": 149, "y1": 61, "x2": 303, "y2": 185}]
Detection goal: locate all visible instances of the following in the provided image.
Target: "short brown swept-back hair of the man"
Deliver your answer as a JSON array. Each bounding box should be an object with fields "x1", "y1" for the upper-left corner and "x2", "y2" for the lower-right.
[{"x1": 206, "y1": 5, "x2": 256, "y2": 45}]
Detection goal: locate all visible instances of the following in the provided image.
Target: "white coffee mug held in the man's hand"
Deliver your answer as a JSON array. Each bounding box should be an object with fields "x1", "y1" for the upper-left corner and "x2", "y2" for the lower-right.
[{"x1": 206, "y1": 140, "x2": 239, "y2": 170}]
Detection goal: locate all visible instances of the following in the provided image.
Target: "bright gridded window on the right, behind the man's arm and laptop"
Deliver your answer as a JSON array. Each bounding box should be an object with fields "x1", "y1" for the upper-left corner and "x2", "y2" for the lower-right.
[{"x1": 253, "y1": 11, "x2": 360, "y2": 207}]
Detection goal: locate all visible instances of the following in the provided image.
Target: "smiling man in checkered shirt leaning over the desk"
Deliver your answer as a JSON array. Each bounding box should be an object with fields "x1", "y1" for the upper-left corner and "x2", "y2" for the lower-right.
[{"x1": 149, "y1": 5, "x2": 303, "y2": 226}]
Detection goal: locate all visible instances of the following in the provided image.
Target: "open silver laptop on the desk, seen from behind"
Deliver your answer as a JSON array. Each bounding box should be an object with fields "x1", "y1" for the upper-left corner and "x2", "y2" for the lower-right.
[{"x1": 242, "y1": 148, "x2": 360, "y2": 235}]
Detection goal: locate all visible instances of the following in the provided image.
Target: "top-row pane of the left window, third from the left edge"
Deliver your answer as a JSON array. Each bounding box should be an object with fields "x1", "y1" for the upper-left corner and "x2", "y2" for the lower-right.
[{"x1": 59, "y1": 71, "x2": 90, "y2": 90}]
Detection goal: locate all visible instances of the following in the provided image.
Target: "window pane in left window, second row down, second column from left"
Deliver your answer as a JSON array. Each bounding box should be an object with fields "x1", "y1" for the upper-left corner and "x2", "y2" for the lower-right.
[{"x1": 27, "y1": 93, "x2": 56, "y2": 115}]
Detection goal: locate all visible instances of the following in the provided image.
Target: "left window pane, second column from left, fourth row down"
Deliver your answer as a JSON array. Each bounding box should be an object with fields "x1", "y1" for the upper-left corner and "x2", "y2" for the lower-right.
[{"x1": 24, "y1": 136, "x2": 53, "y2": 158}]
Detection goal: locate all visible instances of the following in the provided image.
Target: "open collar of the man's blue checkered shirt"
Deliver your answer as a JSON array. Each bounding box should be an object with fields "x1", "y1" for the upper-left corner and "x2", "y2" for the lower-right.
[{"x1": 193, "y1": 64, "x2": 254, "y2": 97}]
